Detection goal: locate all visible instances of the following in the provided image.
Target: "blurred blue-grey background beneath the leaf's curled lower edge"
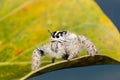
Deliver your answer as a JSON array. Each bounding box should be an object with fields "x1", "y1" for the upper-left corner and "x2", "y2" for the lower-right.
[{"x1": 28, "y1": 65, "x2": 120, "y2": 80}]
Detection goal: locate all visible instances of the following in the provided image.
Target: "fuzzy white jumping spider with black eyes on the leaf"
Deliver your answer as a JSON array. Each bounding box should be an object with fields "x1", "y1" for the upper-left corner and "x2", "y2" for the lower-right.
[{"x1": 32, "y1": 31, "x2": 98, "y2": 71}]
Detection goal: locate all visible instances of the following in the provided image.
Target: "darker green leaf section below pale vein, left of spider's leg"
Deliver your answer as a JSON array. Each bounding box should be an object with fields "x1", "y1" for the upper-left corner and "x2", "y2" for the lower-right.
[{"x1": 0, "y1": 62, "x2": 30, "y2": 80}]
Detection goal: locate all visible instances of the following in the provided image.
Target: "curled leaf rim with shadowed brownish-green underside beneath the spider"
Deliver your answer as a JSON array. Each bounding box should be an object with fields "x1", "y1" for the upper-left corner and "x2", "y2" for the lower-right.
[{"x1": 20, "y1": 55, "x2": 120, "y2": 80}]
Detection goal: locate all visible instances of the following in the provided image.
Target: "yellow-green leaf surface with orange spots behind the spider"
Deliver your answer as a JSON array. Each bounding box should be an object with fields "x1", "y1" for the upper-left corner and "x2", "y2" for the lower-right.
[{"x1": 0, "y1": 0, "x2": 120, "y2": 80}]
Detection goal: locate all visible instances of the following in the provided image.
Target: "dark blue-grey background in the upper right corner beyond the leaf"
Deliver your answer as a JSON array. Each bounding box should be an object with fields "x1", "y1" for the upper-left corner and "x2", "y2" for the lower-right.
[{"x1": 95, "y1": 0, "x2": 120, "y2": 32}]
